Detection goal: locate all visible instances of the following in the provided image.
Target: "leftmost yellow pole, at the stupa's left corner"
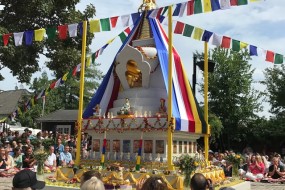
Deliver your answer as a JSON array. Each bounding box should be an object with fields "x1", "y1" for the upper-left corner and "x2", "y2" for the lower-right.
[{"x1": 75, "y1": 21, "x2": 87, "y2": 166}]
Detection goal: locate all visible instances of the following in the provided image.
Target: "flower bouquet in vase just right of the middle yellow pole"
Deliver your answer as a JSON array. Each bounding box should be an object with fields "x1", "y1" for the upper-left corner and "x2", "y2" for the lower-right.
[{"x1": 175, "y1": 154, "x2": 201, "y2": 187}]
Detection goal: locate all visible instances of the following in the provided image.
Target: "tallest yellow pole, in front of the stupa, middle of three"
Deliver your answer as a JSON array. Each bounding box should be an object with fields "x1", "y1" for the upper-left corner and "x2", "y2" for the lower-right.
[{"x1": 167, "y1": 5, "x2": 175, "y2": 170}]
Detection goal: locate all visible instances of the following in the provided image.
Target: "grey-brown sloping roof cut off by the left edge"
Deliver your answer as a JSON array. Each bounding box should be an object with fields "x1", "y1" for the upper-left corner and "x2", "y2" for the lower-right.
[{"x1": 0, "y1": 89, "x2": 30, "y2": 117}]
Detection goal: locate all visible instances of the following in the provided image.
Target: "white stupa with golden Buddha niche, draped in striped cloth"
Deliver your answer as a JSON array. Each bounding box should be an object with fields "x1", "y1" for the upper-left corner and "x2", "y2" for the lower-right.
[{"x1": 83, "y1": 0, "x2": 206, "y2": 162}]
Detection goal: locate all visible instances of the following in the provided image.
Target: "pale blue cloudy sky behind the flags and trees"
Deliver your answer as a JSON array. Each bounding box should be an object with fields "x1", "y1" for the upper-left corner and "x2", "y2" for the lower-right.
[{"x1": 0, "y1": 0, "x2": 285, "y2": 117}]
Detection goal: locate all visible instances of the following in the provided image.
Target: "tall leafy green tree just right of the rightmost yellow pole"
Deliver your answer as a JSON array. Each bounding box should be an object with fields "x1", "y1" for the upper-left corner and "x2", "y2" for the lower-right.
[{"x1": 198, "y1": 48, "x2": 261, "y2": 148}]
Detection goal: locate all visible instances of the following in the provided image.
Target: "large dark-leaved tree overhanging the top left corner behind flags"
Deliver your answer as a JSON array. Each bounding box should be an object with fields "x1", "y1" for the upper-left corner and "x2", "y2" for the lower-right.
[{"x1": 0, "y1": 0, "x2": 95, "y2": 83}]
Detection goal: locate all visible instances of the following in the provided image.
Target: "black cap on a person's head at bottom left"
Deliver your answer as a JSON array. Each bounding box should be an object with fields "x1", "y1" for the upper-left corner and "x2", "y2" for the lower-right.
[{"x1": 13, "y1": 170, "x2": 45, "y2": 189}]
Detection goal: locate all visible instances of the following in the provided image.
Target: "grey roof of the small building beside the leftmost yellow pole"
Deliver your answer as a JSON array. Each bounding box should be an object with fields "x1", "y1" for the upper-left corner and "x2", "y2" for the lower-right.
[{"x1": 37, "y1": 110, "x2": 78, "y2": 122}]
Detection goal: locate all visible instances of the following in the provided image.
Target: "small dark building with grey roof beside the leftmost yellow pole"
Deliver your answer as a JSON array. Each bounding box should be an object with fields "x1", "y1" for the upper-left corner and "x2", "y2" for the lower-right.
[{"x1": 36, "y1": 110, "x2": 78, "y2": 135}]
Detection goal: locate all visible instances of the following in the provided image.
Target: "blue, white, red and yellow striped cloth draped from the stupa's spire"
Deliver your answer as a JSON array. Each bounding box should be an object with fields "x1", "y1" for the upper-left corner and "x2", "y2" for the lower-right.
[{"x1": 83, "y1": 16, "x2": 207, "y2": 134}]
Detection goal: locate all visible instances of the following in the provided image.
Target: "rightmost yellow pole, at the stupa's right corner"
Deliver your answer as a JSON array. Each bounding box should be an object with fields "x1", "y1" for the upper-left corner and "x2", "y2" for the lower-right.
[{"x1": 204, "y1": 42, "x2": 210, "y2": 163}]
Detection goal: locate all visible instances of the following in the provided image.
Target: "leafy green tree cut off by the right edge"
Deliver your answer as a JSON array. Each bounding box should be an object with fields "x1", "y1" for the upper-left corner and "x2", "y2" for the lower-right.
[{"x1": 262, "y1": 65, "x2": 285, "y2": 115}]
